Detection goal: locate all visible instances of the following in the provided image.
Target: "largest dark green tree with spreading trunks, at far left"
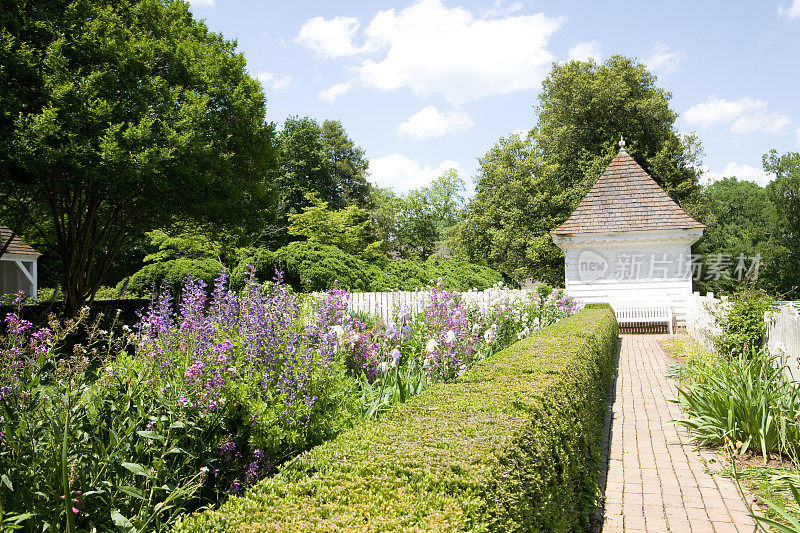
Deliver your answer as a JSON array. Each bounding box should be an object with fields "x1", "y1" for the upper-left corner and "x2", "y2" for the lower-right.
[{"x1": 0, "y1": 0, "x2": 273, "y2": 313}]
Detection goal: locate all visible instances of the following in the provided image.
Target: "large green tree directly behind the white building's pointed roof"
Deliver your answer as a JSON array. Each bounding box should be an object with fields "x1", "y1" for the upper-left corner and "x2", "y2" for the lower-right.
[{"x1": 462, "y1": 56, "x2": 700, "y2": 283}]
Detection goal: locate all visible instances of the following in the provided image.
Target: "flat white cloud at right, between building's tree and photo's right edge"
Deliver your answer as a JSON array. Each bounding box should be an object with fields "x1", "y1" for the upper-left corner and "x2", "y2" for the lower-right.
[{"x1": 683, "y1": 96, "x2": 791, "y2": 134}]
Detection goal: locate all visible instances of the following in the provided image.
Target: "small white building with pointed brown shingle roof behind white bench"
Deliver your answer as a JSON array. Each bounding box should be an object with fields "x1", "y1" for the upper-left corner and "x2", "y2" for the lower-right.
[{"x1": 550, "y1": 140, "x2": 705, "y2": 325}]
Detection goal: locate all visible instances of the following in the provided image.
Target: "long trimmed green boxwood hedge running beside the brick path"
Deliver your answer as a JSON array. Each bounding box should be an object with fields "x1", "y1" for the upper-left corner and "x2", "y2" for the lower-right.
[{"x1": 177, "y1": 306, "x2": 618, "y2": 532}]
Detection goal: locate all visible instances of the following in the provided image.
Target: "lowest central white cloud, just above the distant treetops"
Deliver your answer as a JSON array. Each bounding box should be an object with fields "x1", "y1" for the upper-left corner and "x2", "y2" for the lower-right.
[{"x1": 369, "y1": 154, "x2": 465, "y2": 193}]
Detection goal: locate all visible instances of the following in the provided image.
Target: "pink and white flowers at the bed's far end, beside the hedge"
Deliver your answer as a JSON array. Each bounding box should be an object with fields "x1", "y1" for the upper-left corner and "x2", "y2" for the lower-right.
[{"x1": 322, "y1": 282, "x2": 583, "y2": 416}]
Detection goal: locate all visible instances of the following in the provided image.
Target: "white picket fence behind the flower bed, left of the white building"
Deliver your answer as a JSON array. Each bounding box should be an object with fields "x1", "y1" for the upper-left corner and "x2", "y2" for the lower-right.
[{"x1": 314, "y1": 287, "x2": 530, "y2": 321}]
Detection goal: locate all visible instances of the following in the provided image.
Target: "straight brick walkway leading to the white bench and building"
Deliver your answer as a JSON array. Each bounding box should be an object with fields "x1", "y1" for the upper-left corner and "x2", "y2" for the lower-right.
[{"x1": 603, "y1": 335, "x2": 755, "y2": 533}]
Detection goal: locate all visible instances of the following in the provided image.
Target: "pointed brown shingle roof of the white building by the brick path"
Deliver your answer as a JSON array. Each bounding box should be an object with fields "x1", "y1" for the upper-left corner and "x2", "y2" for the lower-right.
[{"x1": 550, "y1": 149, "x2": 705, "y2": 235}]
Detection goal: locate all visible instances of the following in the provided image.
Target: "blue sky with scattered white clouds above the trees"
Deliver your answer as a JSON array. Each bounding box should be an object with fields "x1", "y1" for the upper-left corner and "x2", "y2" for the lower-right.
[{"x1": 190, "y1": 0, "x2": 800, "y2": 194}]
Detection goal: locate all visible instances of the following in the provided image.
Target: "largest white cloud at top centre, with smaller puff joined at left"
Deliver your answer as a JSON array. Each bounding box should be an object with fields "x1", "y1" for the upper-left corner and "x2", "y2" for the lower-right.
[{"x1": 297, "y1": 0, "x2": 562, "y2": 104}]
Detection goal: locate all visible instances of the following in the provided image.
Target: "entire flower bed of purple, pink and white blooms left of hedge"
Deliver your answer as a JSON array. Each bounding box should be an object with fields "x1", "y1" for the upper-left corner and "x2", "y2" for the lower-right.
[{"x1": 0, "y1": 268, "x2": 580, "y2": 531}]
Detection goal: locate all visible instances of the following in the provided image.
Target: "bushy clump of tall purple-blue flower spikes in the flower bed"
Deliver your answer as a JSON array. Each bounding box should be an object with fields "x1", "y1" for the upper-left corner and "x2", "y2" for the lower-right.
[{"x1": 133, "y1": 269, "x2": 354, "y2": 489}]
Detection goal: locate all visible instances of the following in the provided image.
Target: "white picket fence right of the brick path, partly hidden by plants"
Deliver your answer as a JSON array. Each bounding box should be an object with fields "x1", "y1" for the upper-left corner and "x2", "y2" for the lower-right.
[{"x1": 686, "y1": 293, "x2": 800, "y2": 368}]
